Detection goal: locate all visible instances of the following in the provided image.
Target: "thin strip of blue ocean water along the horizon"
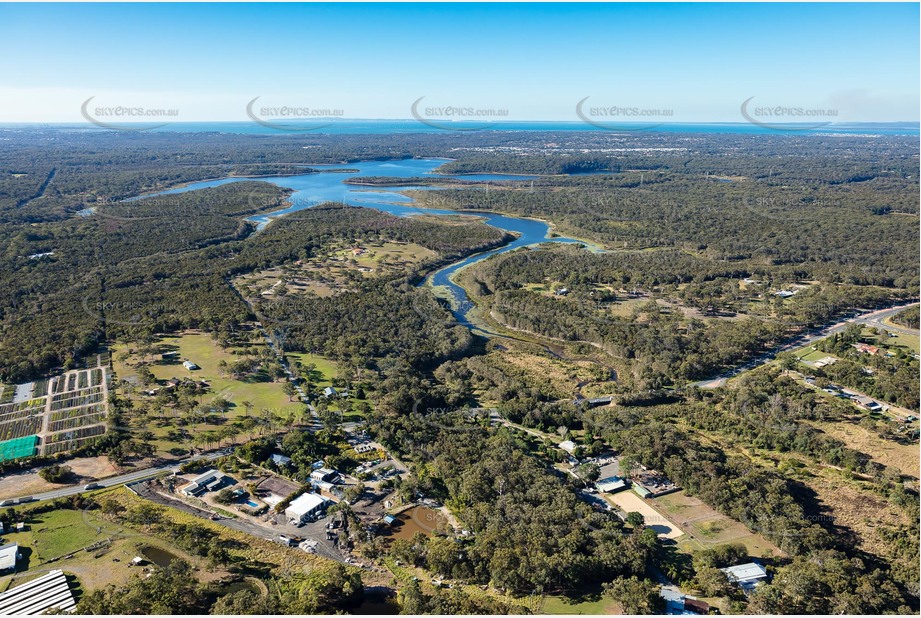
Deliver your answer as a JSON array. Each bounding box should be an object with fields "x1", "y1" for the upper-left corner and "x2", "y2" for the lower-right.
[{"x1": 0, "y1": 120, "x2": 921, "y2": 136}]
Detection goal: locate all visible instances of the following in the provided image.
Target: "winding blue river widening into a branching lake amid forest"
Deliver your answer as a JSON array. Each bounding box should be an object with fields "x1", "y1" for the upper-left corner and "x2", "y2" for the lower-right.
[{"x1": 126, "y1": 159, "x2": 586, "y2": 327}]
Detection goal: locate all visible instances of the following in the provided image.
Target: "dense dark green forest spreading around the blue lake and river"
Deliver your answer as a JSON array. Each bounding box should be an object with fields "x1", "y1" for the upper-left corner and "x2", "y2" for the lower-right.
[{"x1": 0, "y1": 129, "x2": 919, "y2": 613}]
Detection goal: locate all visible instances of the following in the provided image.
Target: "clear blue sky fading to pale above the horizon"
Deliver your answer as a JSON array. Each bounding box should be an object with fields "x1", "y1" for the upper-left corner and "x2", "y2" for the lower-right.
[{"x1": 0, "y1": 3, "x2": 919, "y2": 122}]
